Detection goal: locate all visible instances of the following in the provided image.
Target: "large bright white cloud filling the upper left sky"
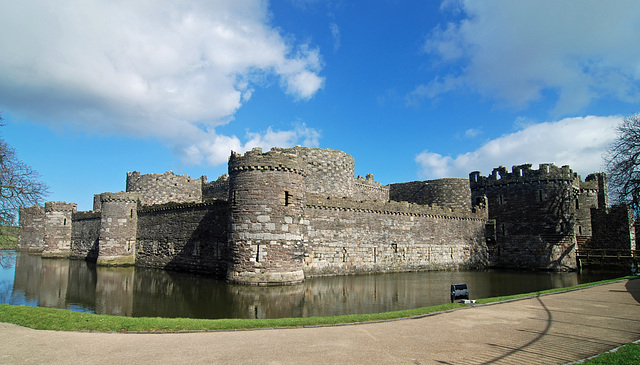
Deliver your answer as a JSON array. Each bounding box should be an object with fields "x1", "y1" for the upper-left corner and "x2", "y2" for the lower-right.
[{"x1": 0, "y1": 0, "x2": 324, "y2": 161}]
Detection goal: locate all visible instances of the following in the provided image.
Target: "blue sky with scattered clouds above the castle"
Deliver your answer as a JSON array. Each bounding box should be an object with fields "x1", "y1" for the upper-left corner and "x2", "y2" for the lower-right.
[{"x1": 0, "y1": 0, "x2": 640, "y2": 210}]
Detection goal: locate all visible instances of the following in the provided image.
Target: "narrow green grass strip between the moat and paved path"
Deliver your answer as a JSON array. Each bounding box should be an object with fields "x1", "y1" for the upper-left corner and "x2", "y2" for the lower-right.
[{"x1": 0, "y1": 277, "x2": 632, "y2": 332}]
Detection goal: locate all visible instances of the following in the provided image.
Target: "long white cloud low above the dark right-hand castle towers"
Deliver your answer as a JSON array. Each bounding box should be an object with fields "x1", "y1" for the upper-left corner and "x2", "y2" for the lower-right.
[{"x1": 415, "y1": 116, "x2": 622, "y2": 179}]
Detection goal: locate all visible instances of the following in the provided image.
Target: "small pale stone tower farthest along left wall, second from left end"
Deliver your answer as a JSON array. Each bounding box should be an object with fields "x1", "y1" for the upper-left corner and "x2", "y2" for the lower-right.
[{"x1": 42, "y1": 202, "x2": 76, "y2": 257}]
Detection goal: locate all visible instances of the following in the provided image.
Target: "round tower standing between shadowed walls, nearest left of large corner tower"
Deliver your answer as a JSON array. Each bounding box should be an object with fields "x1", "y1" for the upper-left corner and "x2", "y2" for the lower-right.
[{"x1": 96, "y1": 192, "x2": 138, "y2": 266}]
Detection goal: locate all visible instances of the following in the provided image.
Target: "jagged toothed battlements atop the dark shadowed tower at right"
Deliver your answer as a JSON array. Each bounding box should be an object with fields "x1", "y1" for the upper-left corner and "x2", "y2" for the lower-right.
[{"x1": 469, "y1": 163, "x2": 580, "y2": 189}]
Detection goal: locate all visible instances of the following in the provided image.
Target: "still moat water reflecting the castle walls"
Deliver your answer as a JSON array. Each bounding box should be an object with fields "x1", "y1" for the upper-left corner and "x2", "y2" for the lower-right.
[{"x1": 0, "y1": 251, "x2": 627, "y2": 318}]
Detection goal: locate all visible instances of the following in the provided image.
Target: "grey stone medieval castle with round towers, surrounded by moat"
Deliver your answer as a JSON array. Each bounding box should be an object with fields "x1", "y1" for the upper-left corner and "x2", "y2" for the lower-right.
[{"x1": 18, "y1": 146, "x2": 635, "y2": 285}]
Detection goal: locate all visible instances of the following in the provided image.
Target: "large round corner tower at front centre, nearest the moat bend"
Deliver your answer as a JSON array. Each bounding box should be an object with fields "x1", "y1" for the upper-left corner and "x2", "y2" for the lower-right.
[{"x1": 227, "y1": 148, "x2": 304, "y2": 285}]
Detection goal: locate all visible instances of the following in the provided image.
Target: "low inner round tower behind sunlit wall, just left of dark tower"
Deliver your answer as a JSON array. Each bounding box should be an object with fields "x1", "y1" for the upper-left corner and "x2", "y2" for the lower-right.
[{"x1": 389, "y1": 178, "x2": 471, "y2": 209}]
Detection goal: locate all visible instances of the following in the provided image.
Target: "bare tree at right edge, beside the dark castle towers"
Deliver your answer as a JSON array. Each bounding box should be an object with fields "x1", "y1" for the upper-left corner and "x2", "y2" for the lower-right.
[{"x1": 605, "y1": 114, "x2": 640, "y2": 212}]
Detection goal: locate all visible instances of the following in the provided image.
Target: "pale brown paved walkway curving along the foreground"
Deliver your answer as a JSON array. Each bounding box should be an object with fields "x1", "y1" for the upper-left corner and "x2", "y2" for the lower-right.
[{"x1": 0, "y1": 279, "x2": 640, "y2": 364}]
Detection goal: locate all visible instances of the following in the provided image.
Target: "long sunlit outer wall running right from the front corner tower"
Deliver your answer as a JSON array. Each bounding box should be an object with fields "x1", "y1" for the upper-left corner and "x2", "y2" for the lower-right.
[{"x1": 304, "y1": 195, "x2": 488, "y2": 276}]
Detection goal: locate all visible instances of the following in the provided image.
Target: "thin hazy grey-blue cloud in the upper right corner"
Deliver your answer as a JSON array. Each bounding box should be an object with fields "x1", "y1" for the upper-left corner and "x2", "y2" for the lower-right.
[{"x1": 416, "y1": 0, "x2": 640, "y2": 115}]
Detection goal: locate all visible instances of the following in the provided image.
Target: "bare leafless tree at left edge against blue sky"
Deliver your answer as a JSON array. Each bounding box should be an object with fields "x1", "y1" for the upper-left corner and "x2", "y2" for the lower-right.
[{"x1": 0, "y1": 114, "x2": 48, "y2": 225}]
